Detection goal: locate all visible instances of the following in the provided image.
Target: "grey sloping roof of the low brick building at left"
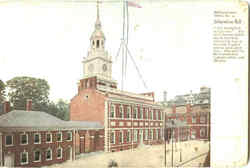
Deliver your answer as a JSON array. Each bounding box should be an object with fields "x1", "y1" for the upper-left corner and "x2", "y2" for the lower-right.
[{"x1": 0, "y1": 110, "x2": 103, "y2": 130}]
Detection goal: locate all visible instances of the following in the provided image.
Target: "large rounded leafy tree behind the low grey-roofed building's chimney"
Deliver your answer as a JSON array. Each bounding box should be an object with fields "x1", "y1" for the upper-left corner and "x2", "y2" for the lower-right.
[{"x1": 6, "y1": 76, "x2": 49, "y2": 111}]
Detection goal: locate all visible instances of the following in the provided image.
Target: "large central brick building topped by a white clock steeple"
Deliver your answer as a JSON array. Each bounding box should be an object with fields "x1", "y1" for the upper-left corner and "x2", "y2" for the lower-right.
[{"x1": 70, "y1": 3, "x2": 164, "y2": 151}]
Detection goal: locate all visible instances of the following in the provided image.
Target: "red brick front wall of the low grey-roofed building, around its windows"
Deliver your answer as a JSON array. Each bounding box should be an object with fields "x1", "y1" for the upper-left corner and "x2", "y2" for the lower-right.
[{"x1": 2, "y1": 131, "x2": 74, "y2": 167}]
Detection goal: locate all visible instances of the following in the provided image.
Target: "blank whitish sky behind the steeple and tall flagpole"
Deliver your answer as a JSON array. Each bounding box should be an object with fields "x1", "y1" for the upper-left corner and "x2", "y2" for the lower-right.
[{"x1": 0, "y1": 0, "x2": 215, "y2": 101}]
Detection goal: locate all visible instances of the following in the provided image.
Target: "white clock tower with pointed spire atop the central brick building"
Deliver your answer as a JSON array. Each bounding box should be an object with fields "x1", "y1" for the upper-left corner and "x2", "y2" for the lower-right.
[{"x1": 83, "y1": 2, "x2": 112, "y2": 81}]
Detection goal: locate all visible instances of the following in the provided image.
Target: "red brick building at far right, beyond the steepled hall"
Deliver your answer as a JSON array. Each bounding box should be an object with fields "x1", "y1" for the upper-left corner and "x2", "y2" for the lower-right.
[{"x1": 161, "y1": 87, "x2": 210, "y2": 141}]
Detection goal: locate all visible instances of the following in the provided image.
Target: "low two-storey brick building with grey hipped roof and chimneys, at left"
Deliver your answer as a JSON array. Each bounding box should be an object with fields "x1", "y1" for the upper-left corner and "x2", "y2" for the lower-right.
[{"x1": 0, "y1": 101, "x2": 103, "y2": 167}]
